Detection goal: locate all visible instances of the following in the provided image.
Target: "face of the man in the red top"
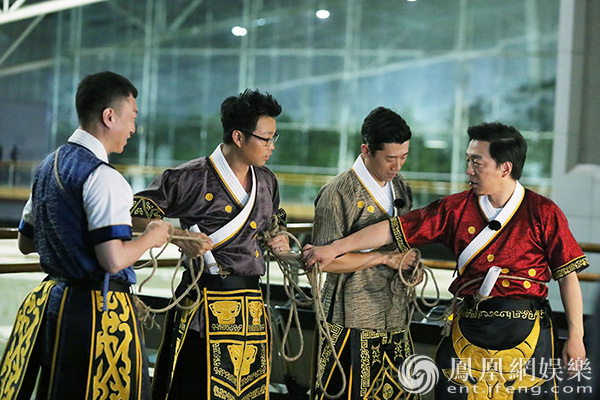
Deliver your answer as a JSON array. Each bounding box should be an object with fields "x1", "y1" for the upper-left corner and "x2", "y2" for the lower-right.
[{"x1": 467, "y1": 140, "x2": 502, "y2": 196}]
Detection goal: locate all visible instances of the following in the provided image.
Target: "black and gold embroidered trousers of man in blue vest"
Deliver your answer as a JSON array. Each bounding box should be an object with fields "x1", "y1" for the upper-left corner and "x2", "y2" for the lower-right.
[{"x1": 0, "y1": 279, "x2": 150, "y2": 399}]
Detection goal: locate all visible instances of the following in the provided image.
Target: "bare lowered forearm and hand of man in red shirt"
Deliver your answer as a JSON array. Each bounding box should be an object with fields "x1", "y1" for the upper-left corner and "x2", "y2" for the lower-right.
[{"x1": 558, "y1": 272, "x2": 585, "y2": 376}]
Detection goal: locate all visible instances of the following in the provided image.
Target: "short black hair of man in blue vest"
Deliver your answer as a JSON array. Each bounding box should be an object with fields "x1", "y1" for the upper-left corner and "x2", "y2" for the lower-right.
[{"x1": 75, "y1": 71, "x2": 137, "y2": 127}]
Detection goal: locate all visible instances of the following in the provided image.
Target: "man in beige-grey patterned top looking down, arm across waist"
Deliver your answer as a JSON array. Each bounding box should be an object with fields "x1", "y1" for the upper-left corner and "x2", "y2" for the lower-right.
[{"x1": 313, "y1": 107, "x2": 420, "y2": 399}]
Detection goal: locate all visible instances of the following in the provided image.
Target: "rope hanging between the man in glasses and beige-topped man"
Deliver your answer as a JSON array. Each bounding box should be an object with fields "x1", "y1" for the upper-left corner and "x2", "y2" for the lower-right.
[{"x1": 261, "y1": 215, "x2": 347, "y2": 399}]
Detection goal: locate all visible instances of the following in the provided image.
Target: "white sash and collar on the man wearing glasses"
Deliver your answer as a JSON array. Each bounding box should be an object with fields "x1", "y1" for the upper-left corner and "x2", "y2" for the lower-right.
[{"x1": 190, "y1": 145, "x2": 257, "y2": 275}]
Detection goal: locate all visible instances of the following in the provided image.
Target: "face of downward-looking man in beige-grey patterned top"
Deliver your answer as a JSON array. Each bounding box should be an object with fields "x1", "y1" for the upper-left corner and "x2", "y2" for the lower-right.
[{"x1": 361, "y1": 140, "x2": 410, "y2": 186}]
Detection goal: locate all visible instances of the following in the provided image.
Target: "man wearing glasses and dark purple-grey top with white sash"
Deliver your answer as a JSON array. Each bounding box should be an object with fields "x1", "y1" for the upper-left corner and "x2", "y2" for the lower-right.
[{"x1": 131, "y1": 90, "x2": 289, "y2": 400}]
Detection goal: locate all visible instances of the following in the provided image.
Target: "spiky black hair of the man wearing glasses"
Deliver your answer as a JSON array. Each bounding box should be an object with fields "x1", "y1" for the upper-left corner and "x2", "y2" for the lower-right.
[{"x1": 221, "y1": 89, "x2": 281, "y2": 143}]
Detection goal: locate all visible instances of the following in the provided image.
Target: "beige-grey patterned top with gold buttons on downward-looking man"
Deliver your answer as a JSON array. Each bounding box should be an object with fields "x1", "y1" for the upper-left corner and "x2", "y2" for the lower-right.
[{"x1": 313, "y1": 170, "x2": 412, "y2": 331}]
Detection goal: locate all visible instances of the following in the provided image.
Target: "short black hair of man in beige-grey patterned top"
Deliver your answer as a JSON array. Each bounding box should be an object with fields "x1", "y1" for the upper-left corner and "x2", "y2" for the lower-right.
[{"x1": 360, "y1": 107, "x2": 411, "y2": 153}]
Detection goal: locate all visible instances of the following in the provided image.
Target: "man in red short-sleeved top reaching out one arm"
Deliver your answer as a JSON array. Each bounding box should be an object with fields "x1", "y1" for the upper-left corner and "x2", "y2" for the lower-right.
[{"x1": 305, "y1": 123, "x2": 589, "y2": 399}]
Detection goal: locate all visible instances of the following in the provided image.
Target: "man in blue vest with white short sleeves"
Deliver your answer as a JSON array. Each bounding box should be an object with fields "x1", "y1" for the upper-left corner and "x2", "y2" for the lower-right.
[{"x1": 0, "y1": 71, "x2": 170, "y2": 400}]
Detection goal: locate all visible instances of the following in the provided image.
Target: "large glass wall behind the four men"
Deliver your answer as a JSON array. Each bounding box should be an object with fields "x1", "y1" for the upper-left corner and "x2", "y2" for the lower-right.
[{"x1": 0, "y1": 0, "x2": 559, "y2": 220}]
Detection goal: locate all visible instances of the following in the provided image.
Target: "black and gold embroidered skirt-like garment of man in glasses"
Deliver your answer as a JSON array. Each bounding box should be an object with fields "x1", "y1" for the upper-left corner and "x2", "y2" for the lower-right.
[{"x1": 153, "y1": 275, "x2": 270, "y2": 400}]
